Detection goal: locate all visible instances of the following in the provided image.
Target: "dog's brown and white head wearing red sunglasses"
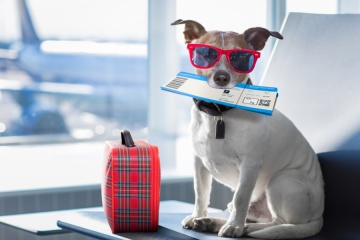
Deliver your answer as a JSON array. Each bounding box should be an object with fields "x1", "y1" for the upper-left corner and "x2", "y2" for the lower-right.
[{"x1": 171, "y1": 19, "x2": 283, "y2": 89}]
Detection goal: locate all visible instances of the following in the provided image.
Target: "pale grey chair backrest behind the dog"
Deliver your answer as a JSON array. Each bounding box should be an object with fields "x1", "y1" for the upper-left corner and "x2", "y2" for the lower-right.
[{"x1": 261, "y1": 13, "x2": 360, "y2": 152}]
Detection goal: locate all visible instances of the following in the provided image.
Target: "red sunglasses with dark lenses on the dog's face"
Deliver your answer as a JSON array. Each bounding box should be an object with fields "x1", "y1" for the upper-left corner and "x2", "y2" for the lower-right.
[{"x1": 187, "y1": 43, "x2": 260, "y2": 73}]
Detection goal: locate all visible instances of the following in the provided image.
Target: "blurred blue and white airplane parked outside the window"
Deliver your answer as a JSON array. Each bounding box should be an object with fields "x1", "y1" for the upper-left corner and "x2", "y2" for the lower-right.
[{"x1": 0, "y1": 0, "x2": 189, "y2": 140}]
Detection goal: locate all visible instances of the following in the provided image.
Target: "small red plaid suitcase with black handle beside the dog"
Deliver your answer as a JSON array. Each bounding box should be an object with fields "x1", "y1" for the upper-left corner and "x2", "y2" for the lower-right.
[{"x1": 101, "y1": 130, "x2": 160, "y2": 233}]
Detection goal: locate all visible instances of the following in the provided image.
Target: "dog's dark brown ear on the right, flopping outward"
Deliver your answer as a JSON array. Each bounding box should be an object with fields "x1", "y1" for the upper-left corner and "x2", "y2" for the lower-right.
[{"x1": 244, "y1": 27, "x2": 283, "y2": 51}]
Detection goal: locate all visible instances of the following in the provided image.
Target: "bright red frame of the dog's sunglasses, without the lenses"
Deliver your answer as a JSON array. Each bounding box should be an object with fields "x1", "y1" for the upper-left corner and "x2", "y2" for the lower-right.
[{"x1": 187, "y1": 43, "x2": 261, "y2": 73}]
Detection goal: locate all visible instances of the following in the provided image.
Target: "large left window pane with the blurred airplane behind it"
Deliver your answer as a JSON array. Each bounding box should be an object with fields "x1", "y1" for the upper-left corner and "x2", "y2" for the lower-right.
[{"x1": 0, "y1": 0, "x2": 147, "y2": 144}]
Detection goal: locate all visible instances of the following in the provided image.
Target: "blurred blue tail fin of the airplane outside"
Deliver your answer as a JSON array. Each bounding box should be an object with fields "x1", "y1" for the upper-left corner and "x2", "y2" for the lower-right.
[{"x1": 18, "y1": 0, "x2": 40, "y2": 44}]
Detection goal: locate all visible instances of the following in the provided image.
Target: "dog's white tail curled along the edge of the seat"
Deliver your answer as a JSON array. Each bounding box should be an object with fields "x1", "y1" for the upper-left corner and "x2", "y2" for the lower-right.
[{"x1": 248, "y1": 218, "x2": 323, "y2": 239}]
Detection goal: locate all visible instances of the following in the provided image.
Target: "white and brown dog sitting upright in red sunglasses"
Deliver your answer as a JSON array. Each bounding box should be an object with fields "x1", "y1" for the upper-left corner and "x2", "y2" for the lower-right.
[{"x1": 171, "y1": 19, "x2": 324, "y2": 239}]
